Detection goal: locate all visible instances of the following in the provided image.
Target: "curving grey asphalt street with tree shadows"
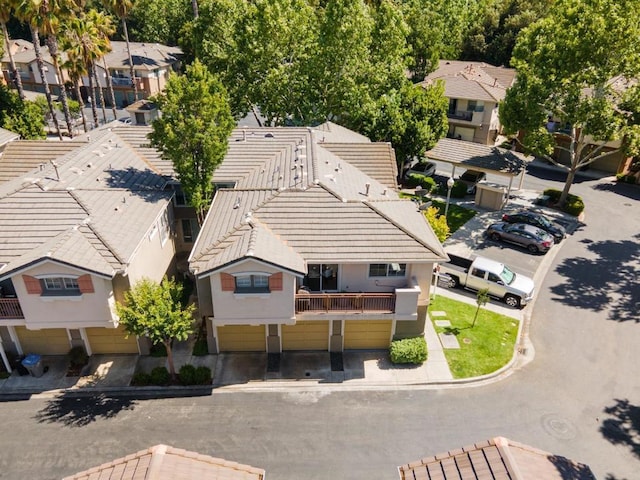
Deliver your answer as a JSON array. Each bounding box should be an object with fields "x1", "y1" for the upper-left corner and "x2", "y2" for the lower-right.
[{"x1": 0, "y1": 174, "x2": 640, "y2": 480}]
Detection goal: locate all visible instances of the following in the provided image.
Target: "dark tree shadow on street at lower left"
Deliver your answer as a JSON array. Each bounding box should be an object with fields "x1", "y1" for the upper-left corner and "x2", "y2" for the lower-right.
[{"x1": 35, "y1": 394, "x2": 136, "y2": 427}]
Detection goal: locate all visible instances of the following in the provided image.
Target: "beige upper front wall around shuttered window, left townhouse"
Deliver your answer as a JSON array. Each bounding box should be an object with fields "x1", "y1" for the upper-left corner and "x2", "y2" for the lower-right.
[{"x1": 12, "y1": 262, "x2": 114, "y2": 329}]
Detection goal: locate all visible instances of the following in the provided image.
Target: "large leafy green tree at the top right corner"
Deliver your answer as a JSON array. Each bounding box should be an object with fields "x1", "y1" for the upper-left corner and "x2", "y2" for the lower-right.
[{"x1": 500, "y1": 0, "x2": 640, "y2": 206}]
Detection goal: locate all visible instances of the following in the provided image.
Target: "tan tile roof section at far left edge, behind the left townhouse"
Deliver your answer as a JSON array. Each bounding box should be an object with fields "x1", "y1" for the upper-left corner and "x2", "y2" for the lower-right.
[{"x1": 0, "y1": 138, "x2": 87, "y2": 184}]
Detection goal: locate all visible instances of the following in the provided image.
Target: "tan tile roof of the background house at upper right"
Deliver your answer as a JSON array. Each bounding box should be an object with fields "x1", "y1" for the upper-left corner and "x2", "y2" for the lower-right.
[{"x1": 422, "y1": 60, "x2": 516, "y2": 102}]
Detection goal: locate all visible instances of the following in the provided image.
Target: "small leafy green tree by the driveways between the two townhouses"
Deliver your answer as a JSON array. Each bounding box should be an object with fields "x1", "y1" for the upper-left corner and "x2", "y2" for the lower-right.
[{"x1": 116, "y1": 278, "x2": 195, "y2": 381}]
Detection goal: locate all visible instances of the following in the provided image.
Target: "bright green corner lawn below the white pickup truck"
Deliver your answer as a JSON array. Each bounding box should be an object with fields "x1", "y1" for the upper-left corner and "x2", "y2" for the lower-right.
[{"x1": 429, "y1": 295, "x2": 518, "y2": 378}]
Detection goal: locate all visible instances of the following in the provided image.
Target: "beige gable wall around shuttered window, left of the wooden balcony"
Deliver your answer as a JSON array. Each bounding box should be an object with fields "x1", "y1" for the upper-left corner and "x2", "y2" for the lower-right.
[{"x1": 208, "y1": 260, "x2": 296, "y2": 325}]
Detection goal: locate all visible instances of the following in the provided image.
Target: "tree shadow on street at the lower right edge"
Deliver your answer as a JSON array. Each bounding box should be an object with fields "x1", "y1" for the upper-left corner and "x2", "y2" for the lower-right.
[{"x1": 600, "y1": 398, "x2": 640, "y2": 464}]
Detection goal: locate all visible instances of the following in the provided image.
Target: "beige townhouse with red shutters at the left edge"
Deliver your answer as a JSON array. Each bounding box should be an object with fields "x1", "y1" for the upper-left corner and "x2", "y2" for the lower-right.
[{"x1": 0, "y1": 124, "x2": 175, "y2": 368}]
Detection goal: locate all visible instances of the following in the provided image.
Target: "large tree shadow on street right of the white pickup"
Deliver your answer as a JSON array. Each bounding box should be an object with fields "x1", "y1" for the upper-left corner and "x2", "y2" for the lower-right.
[{"x1": 551, "y1": 234, "x2": 640, "y2": 322}]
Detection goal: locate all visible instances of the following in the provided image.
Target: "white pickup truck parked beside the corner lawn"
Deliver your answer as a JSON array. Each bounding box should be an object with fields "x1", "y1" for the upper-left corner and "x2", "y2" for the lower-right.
[{"x1": 439, "y1": 254, "x2": 534, "y2": 308}]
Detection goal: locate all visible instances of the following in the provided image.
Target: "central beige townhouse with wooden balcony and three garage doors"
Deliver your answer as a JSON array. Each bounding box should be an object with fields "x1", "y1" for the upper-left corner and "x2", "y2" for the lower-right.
[{"x1": 189, "y1": 123, "x2": 447, "y2": 353}]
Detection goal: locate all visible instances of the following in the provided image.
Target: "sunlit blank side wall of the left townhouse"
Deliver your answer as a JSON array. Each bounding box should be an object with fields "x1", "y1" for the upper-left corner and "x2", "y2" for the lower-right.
[{"x1": 128, "y1": 208, "x2": 176, "y2": 285}]
